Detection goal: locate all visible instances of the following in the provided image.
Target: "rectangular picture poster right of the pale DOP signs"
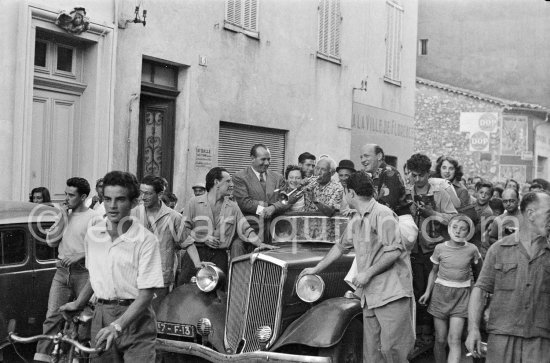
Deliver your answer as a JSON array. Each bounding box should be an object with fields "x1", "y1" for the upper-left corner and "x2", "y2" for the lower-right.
[{"x1": 500, "y1": 115, "x2": 529, "y2": 156}]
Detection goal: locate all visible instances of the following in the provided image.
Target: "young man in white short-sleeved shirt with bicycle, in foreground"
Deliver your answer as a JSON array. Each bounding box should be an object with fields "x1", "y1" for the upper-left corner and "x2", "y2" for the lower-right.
[{"x1": 61, "y1": 171, "x2": 164, "y2": 363}]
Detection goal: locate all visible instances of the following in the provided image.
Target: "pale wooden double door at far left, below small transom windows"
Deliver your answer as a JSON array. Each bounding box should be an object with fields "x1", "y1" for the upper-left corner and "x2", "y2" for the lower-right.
[{"x1": 30, "y1": 89, "x2": 80, "y2": 201}]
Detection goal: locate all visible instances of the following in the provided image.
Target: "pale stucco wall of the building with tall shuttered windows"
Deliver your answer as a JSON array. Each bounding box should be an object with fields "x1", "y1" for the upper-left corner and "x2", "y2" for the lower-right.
[{"x1": 113, "y1": 0, "x2": 417, "y2": 205}]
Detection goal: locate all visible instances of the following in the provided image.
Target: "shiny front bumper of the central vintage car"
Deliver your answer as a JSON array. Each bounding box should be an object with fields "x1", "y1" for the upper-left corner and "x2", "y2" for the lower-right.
[{"x1": 156, "y1": 339, "x2": 332, "y2": 363}]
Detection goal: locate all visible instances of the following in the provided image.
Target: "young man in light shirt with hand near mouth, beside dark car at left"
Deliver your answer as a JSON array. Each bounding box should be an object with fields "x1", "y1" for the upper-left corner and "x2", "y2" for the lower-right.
[{"x1": 34, "y1": 178, "x2": 97, "y2": 362}]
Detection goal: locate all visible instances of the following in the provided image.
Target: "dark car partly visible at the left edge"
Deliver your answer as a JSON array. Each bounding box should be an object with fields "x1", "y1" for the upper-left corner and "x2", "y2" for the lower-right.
[{"x1": 0, "y1": 201, "x2": 57, "y2": 349}]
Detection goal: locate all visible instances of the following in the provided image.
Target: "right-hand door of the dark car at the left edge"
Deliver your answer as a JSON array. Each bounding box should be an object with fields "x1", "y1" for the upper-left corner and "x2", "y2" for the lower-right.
[{"x1": 28, "y1": 223, "x2": 57, "y2": 334}]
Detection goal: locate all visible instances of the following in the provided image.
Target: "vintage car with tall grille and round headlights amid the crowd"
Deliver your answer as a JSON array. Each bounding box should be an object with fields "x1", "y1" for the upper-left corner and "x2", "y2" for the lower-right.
[{"x1": 157, "y1": 214, "x2": 363, "y2": 362}]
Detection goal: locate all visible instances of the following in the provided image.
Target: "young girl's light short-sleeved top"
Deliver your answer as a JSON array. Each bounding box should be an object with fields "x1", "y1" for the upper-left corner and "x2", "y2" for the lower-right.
[{"x1": 430, "y1": 242, "x2": 481, "y2": 287}]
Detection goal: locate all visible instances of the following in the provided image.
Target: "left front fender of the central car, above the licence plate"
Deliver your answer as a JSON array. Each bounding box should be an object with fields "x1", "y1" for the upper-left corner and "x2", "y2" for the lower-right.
[{"x1": 155, "y1": 283, "x2": 227, "y2": 352}]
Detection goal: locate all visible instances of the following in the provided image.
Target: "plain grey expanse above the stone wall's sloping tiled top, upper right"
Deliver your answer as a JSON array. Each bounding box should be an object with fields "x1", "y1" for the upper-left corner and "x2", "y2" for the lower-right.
[{"x1": 417, "y1": 0, "x2": 550, "y2": 107}]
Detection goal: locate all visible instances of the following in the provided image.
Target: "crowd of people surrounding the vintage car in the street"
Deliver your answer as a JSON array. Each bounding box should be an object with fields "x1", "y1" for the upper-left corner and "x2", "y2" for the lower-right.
[{"x1": 30, "y1": 144, "x2": 550, "y2": 363}]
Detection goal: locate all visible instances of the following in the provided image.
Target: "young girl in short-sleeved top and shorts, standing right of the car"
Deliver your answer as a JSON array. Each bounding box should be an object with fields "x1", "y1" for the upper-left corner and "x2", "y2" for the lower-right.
[{"x1": 418, "y1": 214, "x2": 482, "y2": 363}]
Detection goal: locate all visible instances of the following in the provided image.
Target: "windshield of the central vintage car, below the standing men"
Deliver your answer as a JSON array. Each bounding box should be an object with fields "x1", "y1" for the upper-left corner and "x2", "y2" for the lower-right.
[{"x1": 270, "y1": 212, "x2": 349, "y2": 243}]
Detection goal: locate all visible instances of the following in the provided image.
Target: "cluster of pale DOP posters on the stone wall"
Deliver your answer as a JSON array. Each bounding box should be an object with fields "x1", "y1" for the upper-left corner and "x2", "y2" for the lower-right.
[{"x1": 460, "y1": 112, "x2": 498, "y2": 152}]
